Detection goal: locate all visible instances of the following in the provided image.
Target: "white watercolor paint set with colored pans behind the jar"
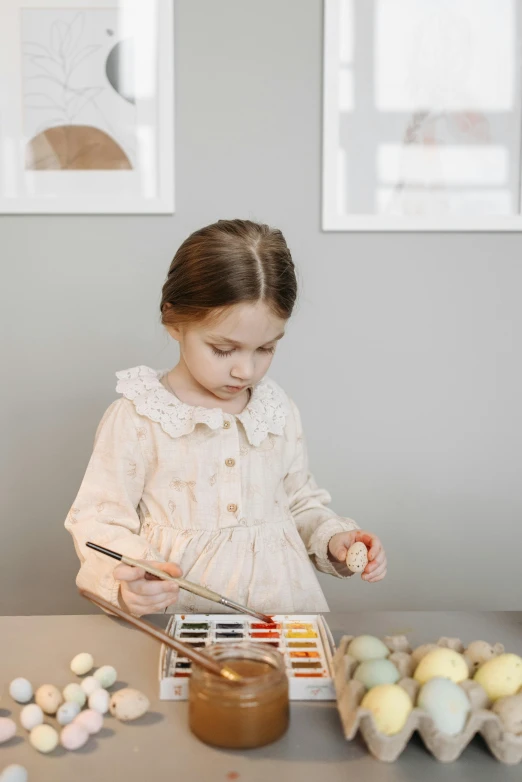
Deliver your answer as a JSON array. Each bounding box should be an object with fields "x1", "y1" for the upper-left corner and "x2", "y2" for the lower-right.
[{"x1": 160, "y1": 614, "x2": 335, "y2": 701}]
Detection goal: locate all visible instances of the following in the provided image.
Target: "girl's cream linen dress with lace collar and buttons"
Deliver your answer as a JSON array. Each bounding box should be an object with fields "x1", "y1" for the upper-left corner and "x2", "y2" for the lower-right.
[{"x1": 65, "y1": 366, "x2": 357, "y2": 614}]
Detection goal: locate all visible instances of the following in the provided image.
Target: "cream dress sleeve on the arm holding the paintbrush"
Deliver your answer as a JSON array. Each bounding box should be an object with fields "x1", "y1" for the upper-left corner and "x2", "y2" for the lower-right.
[{"x1": 65, "y1": 399, "x2": 162, "y2": 605}]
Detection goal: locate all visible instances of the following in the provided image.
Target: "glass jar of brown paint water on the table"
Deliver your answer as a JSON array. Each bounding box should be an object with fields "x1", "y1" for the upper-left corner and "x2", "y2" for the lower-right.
[{"x1": 189, "y1": 641, "x2": 290, "y2": 749}]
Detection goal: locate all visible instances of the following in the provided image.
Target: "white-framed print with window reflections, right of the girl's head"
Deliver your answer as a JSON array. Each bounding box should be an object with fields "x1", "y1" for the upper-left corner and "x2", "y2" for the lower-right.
[{"x1": 322, "y1": 0, "x2": 522, "y2": 231}]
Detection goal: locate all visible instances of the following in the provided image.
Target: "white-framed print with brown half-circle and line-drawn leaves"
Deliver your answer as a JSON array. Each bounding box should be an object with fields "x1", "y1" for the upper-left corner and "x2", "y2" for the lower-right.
[{"x1": 0, "y1": 0, "x2": 174, "y2": 214}]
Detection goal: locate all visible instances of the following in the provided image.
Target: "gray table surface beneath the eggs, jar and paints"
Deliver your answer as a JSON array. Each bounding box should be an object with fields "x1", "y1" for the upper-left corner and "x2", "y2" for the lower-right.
[{"x1": 0, "y1": 611, "x2": 522, "y2": 782}]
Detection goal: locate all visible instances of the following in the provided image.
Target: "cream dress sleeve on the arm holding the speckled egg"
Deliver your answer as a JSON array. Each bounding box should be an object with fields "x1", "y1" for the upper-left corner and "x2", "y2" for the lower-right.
[{"x1": 284, "y1": 400, "x2": 359, "y2": 578}]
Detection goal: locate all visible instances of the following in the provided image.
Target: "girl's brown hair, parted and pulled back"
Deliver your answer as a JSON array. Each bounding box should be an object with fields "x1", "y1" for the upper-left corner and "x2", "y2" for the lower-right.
[{"x1": 160, "y1": 220, "x2": 297, "y2": 326}]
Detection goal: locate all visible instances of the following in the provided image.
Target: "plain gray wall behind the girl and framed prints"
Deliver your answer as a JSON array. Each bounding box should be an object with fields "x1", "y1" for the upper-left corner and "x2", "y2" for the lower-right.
[{"x1": 0, "y1": 0, "x2": 522, "y2": 614}]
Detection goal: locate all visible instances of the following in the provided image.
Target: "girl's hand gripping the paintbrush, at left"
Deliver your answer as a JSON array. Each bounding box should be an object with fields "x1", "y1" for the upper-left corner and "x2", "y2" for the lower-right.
[{"x1": 114, "y1": 562, "x2": 182, "y2": 616}]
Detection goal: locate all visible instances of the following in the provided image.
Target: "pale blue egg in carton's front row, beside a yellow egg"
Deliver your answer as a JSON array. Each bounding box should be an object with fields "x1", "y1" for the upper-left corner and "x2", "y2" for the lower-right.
[{"x1": 417, "y1": 678, "x2": 471, "y2": 736}]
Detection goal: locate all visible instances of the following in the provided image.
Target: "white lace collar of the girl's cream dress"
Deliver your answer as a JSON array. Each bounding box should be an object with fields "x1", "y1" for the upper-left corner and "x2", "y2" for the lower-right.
[{"x1": 116, "y1": 366, "x2": 289, "y2": 446}]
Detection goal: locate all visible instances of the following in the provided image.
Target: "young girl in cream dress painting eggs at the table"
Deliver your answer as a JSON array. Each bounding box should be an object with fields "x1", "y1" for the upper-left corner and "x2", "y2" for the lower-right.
[{"x1": 65, "y1": 220, "x2": 386, "y2": 616}]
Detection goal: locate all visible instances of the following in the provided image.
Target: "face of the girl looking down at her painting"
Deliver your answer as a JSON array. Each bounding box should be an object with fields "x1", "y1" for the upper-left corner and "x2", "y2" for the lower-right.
[{"x1": 168, "y1": 302, "x2": 286, "y2": 400}]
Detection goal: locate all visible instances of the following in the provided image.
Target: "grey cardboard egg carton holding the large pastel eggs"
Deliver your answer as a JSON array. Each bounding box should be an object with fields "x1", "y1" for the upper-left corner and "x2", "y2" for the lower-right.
[{"x1": 333, "y1": 635, "x2": 522, "y2": 765}]
